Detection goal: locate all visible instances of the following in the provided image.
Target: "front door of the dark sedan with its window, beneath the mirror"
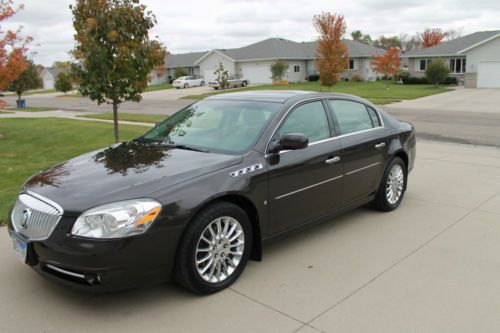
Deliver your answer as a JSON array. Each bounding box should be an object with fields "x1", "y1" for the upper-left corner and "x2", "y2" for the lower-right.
[{"x1": 267, "y1": 100, "x2": 342, "y2": 233}]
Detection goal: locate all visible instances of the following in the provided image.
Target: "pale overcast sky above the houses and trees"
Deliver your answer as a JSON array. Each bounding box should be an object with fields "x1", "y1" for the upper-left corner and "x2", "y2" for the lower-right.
[{"x1": 1, "y1": 0, "x2": 500, "y2": 66}]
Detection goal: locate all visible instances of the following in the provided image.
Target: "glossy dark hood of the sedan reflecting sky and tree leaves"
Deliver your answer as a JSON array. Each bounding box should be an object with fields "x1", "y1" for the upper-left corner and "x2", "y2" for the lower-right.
[{"x1": 24, "y1": 141, "x2": 242, "y2": 215}]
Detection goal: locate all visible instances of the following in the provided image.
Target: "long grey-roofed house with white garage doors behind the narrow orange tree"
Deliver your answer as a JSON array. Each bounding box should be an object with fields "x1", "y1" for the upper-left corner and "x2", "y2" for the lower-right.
[{"x1": 166, "y1": 38, "x2": 384, "y2": 84}]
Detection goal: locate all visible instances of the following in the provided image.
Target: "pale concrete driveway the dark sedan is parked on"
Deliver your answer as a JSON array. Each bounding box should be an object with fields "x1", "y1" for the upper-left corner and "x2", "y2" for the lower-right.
[{"x1": 0, "y1": 141, "x2": 500, "y2": 333}]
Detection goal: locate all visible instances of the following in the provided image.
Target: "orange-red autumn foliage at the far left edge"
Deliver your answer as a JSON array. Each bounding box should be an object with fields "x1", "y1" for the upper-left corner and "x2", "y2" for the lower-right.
[{"x1": 0, "y1": 0, "x2": 32, "y2": 107}]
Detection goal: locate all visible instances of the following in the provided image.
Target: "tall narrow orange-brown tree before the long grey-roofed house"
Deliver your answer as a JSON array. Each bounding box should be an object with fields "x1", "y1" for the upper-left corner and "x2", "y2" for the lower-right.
[{"x1": 313, "y1": 13, "x2": 349, "y2": 89}]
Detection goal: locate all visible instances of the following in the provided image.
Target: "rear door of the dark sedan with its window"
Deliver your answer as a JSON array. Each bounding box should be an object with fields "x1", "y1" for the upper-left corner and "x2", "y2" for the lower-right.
[{"x1": 328, "y1": 99, "x2": 390, "y2": 206}]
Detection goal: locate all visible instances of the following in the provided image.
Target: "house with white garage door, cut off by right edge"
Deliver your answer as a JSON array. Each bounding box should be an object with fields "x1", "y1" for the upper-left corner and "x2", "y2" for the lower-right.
[{"x1": 402, "y1": 30, "x2": 500, "y2": 88}]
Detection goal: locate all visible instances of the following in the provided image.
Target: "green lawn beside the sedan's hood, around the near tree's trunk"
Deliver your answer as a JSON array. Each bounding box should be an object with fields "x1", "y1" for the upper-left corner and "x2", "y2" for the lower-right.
[{"x1": 0, "y1": 118, "x2": 149, "y2": 224}]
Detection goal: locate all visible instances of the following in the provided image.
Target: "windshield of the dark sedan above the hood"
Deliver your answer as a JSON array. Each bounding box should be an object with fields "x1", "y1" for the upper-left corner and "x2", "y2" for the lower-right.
[{"x1": 140, "y1": 100, "x2": 281, "y2": 154}]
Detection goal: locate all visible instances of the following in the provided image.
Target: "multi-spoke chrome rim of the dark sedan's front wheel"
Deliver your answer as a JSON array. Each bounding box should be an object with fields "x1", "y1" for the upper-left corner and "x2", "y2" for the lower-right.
[{"x1": 195, "y1": 216, "x2": 245, "y2": 283}]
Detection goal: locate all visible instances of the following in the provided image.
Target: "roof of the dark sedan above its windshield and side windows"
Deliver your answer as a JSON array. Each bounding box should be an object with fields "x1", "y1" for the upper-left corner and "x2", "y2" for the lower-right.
[{"x1": 206, "y1": 90, "x2": 371, "y2": 104}]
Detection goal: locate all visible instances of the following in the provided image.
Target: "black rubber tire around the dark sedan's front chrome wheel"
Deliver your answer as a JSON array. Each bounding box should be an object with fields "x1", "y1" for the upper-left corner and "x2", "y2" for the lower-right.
[{"x1": 175, "y1": 201, "x2": 252, "y2": 294}]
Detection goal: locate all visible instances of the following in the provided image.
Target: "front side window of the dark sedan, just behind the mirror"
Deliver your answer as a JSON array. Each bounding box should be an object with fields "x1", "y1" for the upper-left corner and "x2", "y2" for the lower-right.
[{"x1": 279, "y1": 101, "x2": 330, "y2": 143}]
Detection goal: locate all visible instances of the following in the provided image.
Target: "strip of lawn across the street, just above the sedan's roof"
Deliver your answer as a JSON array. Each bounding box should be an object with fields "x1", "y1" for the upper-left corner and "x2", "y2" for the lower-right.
[{"x1": 183, "y1": 81, "x2": 449, "y2": 104}]
